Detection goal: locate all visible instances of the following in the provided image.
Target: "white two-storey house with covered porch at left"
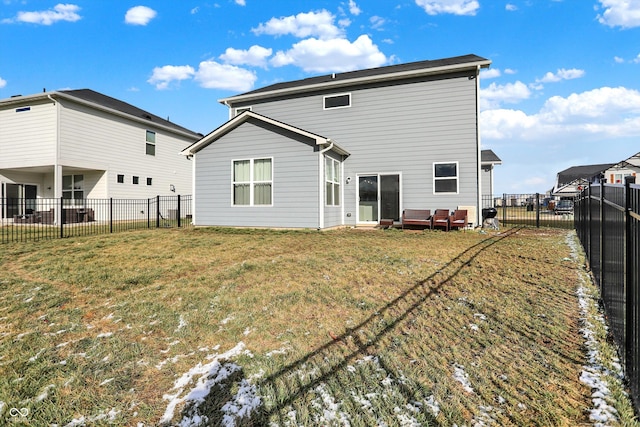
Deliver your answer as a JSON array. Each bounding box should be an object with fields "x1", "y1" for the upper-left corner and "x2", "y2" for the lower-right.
[{"x1": 0, "y1": 89, "x2": 202, "y2": 218}]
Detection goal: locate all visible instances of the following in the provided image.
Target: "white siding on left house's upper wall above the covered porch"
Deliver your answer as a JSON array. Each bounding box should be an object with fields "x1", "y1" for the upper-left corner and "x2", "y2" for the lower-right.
[{"x1": 0, "y1": 102, "x2": 56, "y2": 169}]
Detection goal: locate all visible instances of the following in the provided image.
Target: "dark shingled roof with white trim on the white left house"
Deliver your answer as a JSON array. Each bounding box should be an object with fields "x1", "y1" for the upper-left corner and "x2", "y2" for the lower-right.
[{"x1": 0, "y1": 89, "x2": 202, "y2": 139}]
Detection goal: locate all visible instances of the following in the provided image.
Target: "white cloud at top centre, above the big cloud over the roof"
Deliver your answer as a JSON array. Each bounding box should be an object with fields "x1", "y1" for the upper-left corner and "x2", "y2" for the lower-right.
[{"x1": 251, "y1": 10, "x2": 342, "y2": 40}]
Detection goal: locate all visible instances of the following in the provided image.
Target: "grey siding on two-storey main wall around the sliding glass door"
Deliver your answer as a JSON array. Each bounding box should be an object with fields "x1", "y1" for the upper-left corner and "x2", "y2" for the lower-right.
[{"x1": 238, "y1": 74, "x2": 479, "y2": 224}]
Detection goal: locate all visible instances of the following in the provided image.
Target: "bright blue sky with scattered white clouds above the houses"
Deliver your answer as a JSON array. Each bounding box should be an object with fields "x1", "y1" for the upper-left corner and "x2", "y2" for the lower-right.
[{"x1": 0, "y1": 0, "x2": 640, "y2": 194}]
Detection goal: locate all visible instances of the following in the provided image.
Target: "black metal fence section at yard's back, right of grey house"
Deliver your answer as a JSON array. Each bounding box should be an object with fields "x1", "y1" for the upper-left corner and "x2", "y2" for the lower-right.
[{"x1": 482, "y1": 193, "x2": 574, "y2": 228}]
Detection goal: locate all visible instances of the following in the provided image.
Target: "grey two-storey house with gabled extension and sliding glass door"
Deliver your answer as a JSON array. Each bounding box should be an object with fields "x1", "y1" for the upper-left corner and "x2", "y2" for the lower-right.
[{"x1": 182, "y1": 55, "x2": 495, "y2": 229}]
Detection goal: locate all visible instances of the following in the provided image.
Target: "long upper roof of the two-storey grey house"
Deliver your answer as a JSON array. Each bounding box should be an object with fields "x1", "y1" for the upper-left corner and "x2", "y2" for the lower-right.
[{"x1": 219, "y1": 54, "x2": 491, "y2": 105}]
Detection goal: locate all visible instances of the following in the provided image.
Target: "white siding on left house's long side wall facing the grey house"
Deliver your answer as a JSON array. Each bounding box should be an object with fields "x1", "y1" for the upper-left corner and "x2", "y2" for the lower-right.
[{"x1": 59, "y1": 101, "x2": 193, "y2": 199}]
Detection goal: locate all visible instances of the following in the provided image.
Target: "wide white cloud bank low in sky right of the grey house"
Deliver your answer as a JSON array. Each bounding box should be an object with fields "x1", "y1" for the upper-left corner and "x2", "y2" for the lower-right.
[{"x1": 480, "y1": 87, "x2": 640, "y2": 141}]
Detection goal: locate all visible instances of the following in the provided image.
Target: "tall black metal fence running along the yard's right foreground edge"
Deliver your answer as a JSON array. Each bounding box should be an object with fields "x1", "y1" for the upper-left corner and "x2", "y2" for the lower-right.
[{"x1": 575, "y1": 181, "x2": 640, "y2": 412}]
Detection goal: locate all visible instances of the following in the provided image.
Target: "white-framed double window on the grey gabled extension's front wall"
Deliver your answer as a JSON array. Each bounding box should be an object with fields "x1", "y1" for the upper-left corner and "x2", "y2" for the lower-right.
[{"x1": 232, "y1": 159, "x2": 273, "y2": 206}]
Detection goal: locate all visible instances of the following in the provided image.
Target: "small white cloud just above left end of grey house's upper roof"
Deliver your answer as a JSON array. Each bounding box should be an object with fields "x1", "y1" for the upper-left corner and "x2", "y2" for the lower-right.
[{"x1": 195, "y1": 60, "x2": 257, "y2": 92}]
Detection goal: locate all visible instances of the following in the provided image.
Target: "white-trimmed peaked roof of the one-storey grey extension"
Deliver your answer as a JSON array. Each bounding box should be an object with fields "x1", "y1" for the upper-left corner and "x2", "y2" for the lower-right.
[{"x1": 180, "y1": 110, "x2": 349, "y2": 156}]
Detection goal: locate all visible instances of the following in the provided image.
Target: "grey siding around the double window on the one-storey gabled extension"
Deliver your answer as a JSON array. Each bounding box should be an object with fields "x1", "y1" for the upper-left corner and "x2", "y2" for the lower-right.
[{"x1": 195, "y1": 120, "x2": 319, "y2": 228}]
